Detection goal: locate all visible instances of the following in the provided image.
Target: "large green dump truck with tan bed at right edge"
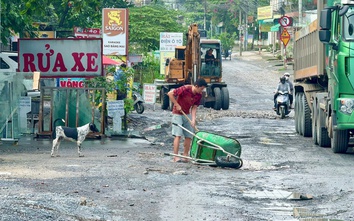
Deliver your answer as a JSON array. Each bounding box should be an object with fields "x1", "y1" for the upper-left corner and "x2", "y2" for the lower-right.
[{"x1": 294, "y1": 0, "x2": 354, "y2": 153}]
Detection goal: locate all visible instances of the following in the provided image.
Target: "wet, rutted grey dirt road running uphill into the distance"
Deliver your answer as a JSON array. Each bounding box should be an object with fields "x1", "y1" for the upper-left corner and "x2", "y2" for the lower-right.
[{"x1": 0, "y1": 52, "x2": 354, "y2": 221}]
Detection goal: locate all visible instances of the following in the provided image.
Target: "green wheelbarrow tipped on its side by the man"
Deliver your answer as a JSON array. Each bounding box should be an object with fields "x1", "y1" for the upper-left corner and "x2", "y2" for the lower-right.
[{"x1": 165, "y1": 124, "x2": 243, "y2": 169}]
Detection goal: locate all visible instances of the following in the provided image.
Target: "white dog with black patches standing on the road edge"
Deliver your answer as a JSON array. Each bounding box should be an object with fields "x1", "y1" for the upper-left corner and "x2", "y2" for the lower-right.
[{"x1": 51, "y1": 119, "x2": 98, "y2": 157}]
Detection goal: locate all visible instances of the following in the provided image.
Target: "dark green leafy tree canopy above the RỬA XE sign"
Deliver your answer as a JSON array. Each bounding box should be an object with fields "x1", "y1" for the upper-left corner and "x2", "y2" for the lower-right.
[{"x1": 1, "y1": 0, "x2": 132, "y2": 44}]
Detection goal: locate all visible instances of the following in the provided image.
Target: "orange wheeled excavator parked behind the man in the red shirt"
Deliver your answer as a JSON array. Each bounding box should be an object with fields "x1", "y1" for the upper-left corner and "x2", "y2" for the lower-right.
[{"x1": 155, "y1": 24, "x2": 229, "y2": 110}]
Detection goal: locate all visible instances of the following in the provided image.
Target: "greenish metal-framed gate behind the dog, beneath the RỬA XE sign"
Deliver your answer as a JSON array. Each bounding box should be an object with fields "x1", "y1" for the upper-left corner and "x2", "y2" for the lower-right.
[{"x1": 37, "y1": 87, "x2": 106, "y2": 137}]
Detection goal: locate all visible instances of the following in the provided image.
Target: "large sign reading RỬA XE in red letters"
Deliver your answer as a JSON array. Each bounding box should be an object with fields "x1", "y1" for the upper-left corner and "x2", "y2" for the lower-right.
[{"x1": 18, "y1": 38, "x2": 103, "y2": 78}]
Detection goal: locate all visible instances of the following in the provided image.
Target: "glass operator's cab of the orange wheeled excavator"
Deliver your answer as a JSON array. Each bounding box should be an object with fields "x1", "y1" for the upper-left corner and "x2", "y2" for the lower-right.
[{"x1": 200, "y1": 39, "x2": 222, "y2": 83}]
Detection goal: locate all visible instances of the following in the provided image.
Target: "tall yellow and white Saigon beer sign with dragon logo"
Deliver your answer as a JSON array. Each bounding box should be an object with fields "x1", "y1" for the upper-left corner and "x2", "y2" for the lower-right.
[{"x1": 102, "y1": 8, "x2": 129, "y2": 55}]
